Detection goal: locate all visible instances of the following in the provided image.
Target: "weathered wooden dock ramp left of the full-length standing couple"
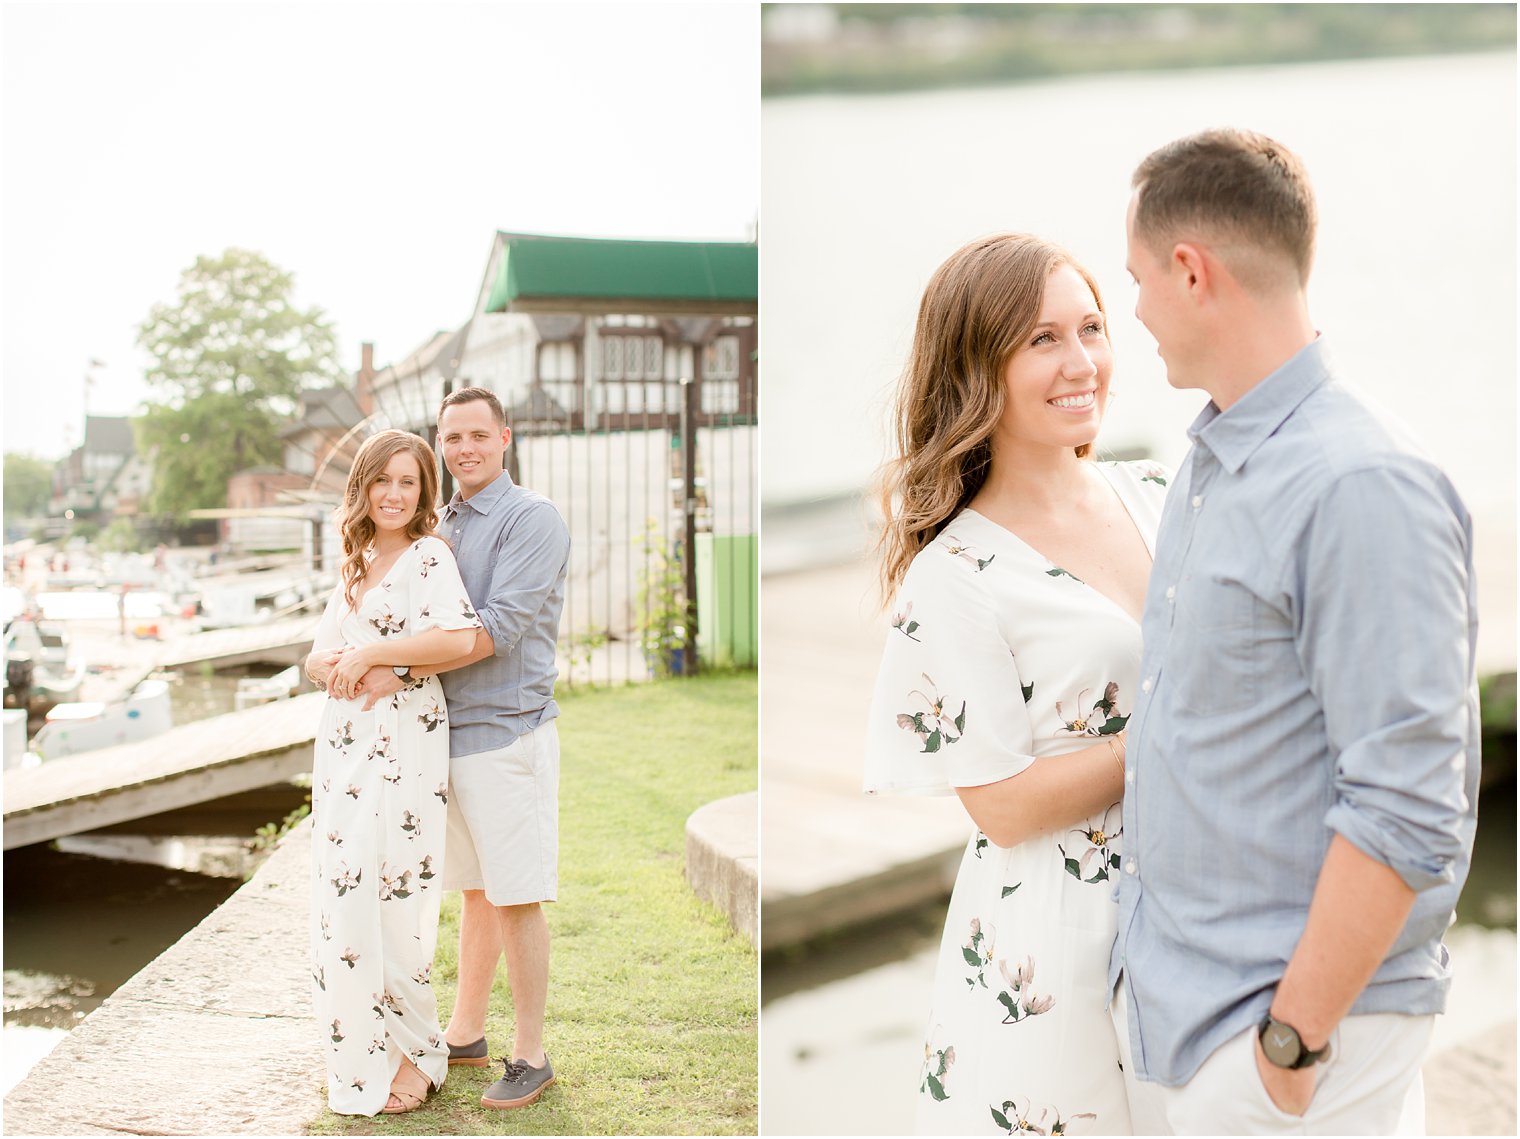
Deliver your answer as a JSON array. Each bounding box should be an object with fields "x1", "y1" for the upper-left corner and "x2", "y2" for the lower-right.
[{"x1": 5, "y1": 692, "x2": 327, "y2": 850}]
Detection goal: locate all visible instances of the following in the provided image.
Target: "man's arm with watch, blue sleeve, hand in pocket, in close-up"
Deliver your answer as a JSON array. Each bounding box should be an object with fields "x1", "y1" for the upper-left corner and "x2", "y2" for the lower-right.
[{"x1": 1257, "y1": 470, "x2": 1471, "y2": 1115}]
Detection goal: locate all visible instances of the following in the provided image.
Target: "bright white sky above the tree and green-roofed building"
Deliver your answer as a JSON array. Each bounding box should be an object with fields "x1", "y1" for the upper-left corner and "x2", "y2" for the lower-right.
[{"x1": 0, "y1": 0, "x2": 760, "y2": 458}]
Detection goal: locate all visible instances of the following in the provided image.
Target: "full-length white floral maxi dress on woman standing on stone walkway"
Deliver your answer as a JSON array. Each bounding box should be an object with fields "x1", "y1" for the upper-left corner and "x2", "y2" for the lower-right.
[{"x1": 312, "y1": 537, "x2": 480, "y2": 1115}]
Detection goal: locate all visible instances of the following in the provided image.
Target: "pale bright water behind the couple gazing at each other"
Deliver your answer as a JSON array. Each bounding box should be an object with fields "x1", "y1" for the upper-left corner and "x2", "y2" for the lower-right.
[{"x1": 760, "y1": 53, "x2": 1515, "y2": 671}]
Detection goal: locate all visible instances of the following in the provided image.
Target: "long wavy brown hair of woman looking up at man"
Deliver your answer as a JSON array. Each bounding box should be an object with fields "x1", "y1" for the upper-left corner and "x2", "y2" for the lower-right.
[{"x1": 877, "y1": 233, "x2": 1108, "y2": 604}]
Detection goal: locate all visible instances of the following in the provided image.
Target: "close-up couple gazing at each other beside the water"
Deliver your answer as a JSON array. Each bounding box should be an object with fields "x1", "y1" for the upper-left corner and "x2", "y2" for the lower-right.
[{"x1": 866, "y1": 129, "x2": 1479, "y2": 1134}]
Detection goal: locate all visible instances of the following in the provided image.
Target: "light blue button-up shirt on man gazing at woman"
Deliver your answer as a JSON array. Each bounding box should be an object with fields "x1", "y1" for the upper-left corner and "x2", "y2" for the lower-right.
[{"x1": 1110, "y1": 339, "x2": 1479, "y2": 1086}]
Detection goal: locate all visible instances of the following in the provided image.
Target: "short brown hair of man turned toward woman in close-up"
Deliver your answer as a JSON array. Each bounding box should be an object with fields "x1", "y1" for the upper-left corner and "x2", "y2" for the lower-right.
[{"x1": 1131, "y1": 128, "x2": 1316, "y2": 287}]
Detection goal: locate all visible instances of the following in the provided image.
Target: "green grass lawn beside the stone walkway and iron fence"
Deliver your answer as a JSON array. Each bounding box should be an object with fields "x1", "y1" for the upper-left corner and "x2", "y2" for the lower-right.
[{"x1": 309, "y1": 672, "x2": 758, "y2": 1134}]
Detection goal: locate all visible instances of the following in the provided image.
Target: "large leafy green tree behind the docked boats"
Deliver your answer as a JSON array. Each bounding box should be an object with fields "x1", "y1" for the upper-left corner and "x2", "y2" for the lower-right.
[{"x1": 137, "y1": 249, "x2": 342, "y2": 519}]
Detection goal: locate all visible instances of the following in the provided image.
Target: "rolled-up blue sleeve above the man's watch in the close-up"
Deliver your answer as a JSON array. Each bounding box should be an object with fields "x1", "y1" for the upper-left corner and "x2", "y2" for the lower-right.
[{"x1": 1294, "y1": 464, "x2": 1474, "y2": 891}]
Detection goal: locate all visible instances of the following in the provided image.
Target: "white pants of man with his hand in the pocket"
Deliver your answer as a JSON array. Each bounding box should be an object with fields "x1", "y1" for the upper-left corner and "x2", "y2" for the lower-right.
[{"x1": 1111, "y1": 978, "x2": 1435, "y2": 1134}]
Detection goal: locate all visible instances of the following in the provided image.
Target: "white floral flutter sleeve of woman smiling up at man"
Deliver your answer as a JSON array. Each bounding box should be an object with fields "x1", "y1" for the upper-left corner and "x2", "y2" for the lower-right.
[{"x1": 865, "y1": 543, "x2": 1034, "y2": 794}]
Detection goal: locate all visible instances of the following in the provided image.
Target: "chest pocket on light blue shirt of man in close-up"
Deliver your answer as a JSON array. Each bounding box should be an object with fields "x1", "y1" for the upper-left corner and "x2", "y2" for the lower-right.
[{"x1": 1167, "y1": 572, "x2": 1269, "y2": 716}]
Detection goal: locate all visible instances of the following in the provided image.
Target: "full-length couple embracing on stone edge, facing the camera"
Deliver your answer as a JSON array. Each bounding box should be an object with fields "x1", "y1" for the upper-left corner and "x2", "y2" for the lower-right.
[{"x1": 306, "y1": 388, "x2": 570, "y2": 1115}]
